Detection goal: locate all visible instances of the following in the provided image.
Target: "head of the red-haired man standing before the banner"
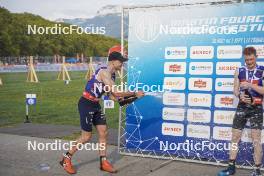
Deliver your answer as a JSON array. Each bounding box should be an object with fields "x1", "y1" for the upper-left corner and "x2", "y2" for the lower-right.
[{"x1": 243, "y1": 47, "x2": 257, "y2": 69}]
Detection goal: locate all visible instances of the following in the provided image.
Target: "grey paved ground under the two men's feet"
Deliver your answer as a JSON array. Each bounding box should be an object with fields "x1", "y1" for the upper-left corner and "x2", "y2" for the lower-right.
[{"x1": 0, "y1": 133, "x2": 254, "y2": 176}]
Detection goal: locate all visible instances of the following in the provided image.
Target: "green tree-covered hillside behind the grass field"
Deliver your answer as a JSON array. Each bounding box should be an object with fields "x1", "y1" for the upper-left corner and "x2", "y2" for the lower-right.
[{"x1": 0, "y1": 7, "x2": 119, "y2": 56}]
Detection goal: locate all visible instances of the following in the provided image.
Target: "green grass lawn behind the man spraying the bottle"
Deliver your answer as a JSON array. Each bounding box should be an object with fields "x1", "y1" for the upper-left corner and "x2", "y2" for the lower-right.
[{"x1": 0, "y1": 72, "x2": 119, "y2": 128}]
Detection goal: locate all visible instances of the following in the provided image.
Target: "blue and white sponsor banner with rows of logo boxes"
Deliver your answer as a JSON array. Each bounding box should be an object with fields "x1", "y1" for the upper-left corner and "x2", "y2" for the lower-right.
[{"x1": 125, "y1": 2, "x2": 264, "y2": 165}]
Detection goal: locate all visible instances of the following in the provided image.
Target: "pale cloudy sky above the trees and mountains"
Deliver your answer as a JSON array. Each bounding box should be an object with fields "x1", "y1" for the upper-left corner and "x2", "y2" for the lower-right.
[{"x1": 0, "y1": 0, "x2": 224, "y2": 20}]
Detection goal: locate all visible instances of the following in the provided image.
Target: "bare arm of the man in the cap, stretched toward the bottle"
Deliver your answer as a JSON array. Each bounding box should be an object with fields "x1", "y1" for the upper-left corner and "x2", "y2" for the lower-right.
[{"x1": 98, "y1": 70, "x2": 144, "y2": 98}]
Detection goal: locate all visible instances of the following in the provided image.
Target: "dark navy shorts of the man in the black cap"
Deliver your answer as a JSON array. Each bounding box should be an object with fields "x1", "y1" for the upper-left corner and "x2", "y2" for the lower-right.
[{"x1": 78, "y1": 97, "x2": 106, "y2": 132}]
